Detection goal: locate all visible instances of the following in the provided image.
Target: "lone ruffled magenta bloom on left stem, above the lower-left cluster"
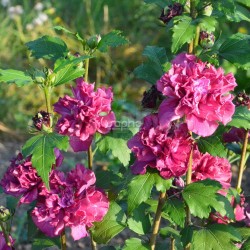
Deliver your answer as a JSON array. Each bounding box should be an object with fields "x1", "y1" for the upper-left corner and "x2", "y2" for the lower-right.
[{"x1": 54, "y1": 78, "x2": 115, "y2": 152}]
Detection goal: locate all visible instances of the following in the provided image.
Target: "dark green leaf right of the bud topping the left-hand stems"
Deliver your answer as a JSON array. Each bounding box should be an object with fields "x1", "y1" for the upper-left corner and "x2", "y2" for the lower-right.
[{"x1": 97, "y1": 30, "x2": 129, "y2": 52}]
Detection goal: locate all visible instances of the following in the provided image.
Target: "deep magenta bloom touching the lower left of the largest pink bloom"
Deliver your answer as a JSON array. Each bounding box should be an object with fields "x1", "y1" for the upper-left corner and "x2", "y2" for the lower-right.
[{"x1": 128, "y1": 114, "x2": 192, "y2": 179}]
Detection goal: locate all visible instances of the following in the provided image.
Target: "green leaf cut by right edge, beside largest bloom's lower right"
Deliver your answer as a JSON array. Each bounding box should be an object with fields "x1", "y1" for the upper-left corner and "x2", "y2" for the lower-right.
[{"x1": 227, "y1": 106, "x2": 250, "y2": 129}]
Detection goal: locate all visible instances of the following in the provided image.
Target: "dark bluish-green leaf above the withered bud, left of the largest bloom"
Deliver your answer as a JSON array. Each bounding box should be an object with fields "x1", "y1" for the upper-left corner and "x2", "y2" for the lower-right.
[{"x1": 134, "y1": 46, "x2": 168, "y2": 84}]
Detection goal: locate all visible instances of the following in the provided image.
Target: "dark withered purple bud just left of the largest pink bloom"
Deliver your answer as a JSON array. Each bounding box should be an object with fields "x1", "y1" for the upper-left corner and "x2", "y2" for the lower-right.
[{"x1": 141, "y1": 85, "x2": 162, "y2": 109}]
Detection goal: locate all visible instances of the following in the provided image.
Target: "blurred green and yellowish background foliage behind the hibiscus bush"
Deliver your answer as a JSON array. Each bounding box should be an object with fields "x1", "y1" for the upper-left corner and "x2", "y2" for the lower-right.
[{"x1": 0, "y1": 0, "x2": 250, "y2": 135}]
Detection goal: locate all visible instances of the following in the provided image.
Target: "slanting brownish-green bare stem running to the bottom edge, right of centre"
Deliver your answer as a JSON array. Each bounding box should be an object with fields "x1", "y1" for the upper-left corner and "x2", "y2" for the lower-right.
[{"x1": 150, "y1": 192, "x2": 167, "y2": 250}]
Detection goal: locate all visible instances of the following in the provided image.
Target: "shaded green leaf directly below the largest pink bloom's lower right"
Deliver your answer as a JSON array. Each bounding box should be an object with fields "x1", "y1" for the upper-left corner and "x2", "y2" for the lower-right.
[{"x1": 198, "y1": 136, "x2": 227, "y2": 158}]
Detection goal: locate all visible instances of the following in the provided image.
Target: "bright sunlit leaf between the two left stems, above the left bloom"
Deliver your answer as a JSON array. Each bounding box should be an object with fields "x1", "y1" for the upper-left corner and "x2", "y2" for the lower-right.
[{"x1": 53, "y1": 56, "x2": 91, "y2": 86}]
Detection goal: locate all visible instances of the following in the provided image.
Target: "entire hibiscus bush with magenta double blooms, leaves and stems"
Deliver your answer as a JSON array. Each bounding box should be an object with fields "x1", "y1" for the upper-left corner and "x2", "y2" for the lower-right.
[{"x1": 0, "y1": 0, "x2": 250, "y2": 250}]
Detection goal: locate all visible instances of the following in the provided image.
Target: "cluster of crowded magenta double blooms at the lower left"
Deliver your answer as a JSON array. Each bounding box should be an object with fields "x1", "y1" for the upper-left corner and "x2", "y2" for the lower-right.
[{"x1": 1, "y1": 154, "x2": 109, "y2": 240}]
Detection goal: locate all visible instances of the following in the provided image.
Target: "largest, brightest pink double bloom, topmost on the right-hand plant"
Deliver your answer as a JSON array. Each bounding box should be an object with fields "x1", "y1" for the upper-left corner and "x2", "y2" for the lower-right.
[{"x1": 157, "y1": 53, "x2": 236, "y2": 136}]
